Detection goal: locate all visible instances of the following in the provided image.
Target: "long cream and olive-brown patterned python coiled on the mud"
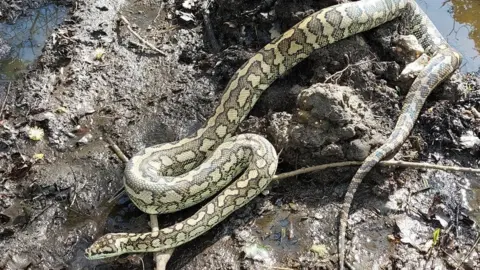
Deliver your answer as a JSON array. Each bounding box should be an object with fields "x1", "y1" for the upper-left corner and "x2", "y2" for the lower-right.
[{"x1": 86, "y1": 0, "x2": 462, "y2": 269}]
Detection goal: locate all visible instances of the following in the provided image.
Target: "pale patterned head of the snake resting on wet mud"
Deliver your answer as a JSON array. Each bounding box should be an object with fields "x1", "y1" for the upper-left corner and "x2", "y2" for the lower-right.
[{"x1": 85, "y1": 233, "x2": 129, "y2": 260}]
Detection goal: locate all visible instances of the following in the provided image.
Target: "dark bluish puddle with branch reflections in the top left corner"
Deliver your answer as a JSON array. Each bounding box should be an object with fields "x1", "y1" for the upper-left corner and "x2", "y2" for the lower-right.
[{"x1": 0, "y1": 4, "x2": 68, "y2": 80}]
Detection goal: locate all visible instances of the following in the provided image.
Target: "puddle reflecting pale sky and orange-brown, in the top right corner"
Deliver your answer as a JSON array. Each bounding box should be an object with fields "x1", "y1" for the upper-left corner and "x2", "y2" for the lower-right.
[{"x1": 416, "y1": 0, "x2": 480, "y2": 72}]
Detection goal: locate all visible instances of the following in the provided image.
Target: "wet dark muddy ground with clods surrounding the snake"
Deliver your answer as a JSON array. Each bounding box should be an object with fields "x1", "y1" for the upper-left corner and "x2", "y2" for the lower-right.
[{"x1": 0, "y1": 0, "x2": 480, "y2": 269}]
